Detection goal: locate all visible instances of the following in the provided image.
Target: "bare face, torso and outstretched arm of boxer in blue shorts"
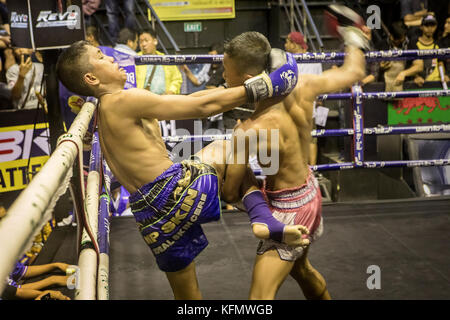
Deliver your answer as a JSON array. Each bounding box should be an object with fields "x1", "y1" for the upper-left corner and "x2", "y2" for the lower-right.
[{"x1": 80, "y1": 46, "x2": 247, "y2": 193}]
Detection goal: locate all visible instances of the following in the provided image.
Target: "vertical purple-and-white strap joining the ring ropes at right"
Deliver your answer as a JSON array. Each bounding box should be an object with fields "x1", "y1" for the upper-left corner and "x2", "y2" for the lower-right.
[{"x1": 352, "y1": 85, "x2": 364, "y2": 167}]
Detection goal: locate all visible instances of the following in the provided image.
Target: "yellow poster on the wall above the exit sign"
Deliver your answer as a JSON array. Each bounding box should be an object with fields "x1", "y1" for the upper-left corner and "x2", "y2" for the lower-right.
[{"x1": 149, "y1": 0, "x2": 235, "y2": 21}]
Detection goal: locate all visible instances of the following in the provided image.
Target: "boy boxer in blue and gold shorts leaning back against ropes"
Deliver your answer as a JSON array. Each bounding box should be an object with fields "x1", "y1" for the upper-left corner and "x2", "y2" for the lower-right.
[{"x1": 57, "y1": 41, "x2": 302, "y2": 299}]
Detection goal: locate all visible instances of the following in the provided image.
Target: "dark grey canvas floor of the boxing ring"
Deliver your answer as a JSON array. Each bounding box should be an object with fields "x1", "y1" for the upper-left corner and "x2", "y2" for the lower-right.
[{"x1": 29, "y1": 198, "x2": 450, "y2": 300}]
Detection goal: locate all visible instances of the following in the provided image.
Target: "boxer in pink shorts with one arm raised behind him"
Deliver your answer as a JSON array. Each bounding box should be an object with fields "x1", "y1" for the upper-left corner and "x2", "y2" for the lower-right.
[{"x1": 223, "y1": 8, "x2": 367, "y2": 300}]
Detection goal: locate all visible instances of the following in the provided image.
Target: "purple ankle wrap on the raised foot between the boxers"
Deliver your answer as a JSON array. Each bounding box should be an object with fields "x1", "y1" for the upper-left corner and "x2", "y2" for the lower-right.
[{"x1": 242, "y1": 190, "x2": 285, "y2": 242}]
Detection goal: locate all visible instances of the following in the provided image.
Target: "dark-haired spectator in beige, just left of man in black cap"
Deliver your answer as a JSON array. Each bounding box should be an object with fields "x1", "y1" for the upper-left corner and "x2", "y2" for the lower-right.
[{"x1": 380, "y1": 21, "x2": 409, "y2": 92}]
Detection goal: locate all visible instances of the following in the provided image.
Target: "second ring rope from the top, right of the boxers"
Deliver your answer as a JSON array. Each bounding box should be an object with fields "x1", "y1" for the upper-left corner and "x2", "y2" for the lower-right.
[{"x1": 317, "y1": 90, "x2": 450, "y2": 100}]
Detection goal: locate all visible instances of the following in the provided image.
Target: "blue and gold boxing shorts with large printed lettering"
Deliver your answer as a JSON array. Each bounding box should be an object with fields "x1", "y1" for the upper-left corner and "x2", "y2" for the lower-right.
[{"x1": 130, "y1": 160, "x2": 221, "y2": 272}]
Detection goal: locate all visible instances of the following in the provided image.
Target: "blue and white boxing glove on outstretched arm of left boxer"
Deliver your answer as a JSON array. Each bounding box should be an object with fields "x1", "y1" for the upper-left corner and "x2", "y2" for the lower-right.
[{"x1": 244, "y1": 49, "x2": 298, "y2": 102}]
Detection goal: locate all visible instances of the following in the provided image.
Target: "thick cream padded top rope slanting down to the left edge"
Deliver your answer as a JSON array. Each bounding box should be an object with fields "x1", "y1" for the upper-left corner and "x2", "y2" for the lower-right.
[{"x1": 0, "y1": 100, "x2": 96, "y2": 292}]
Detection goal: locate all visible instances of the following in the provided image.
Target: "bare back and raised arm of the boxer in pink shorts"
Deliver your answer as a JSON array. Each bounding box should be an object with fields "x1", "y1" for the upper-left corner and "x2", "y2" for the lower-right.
[{"x1": 224, "y1": 47, "x2": 365, "y2": 202}]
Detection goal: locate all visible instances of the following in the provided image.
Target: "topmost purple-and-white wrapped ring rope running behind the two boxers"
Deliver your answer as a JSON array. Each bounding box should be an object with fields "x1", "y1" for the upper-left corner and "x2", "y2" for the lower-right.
[{"x1": 134, "y1": 48, "x2": 450, "y2": 65}]
